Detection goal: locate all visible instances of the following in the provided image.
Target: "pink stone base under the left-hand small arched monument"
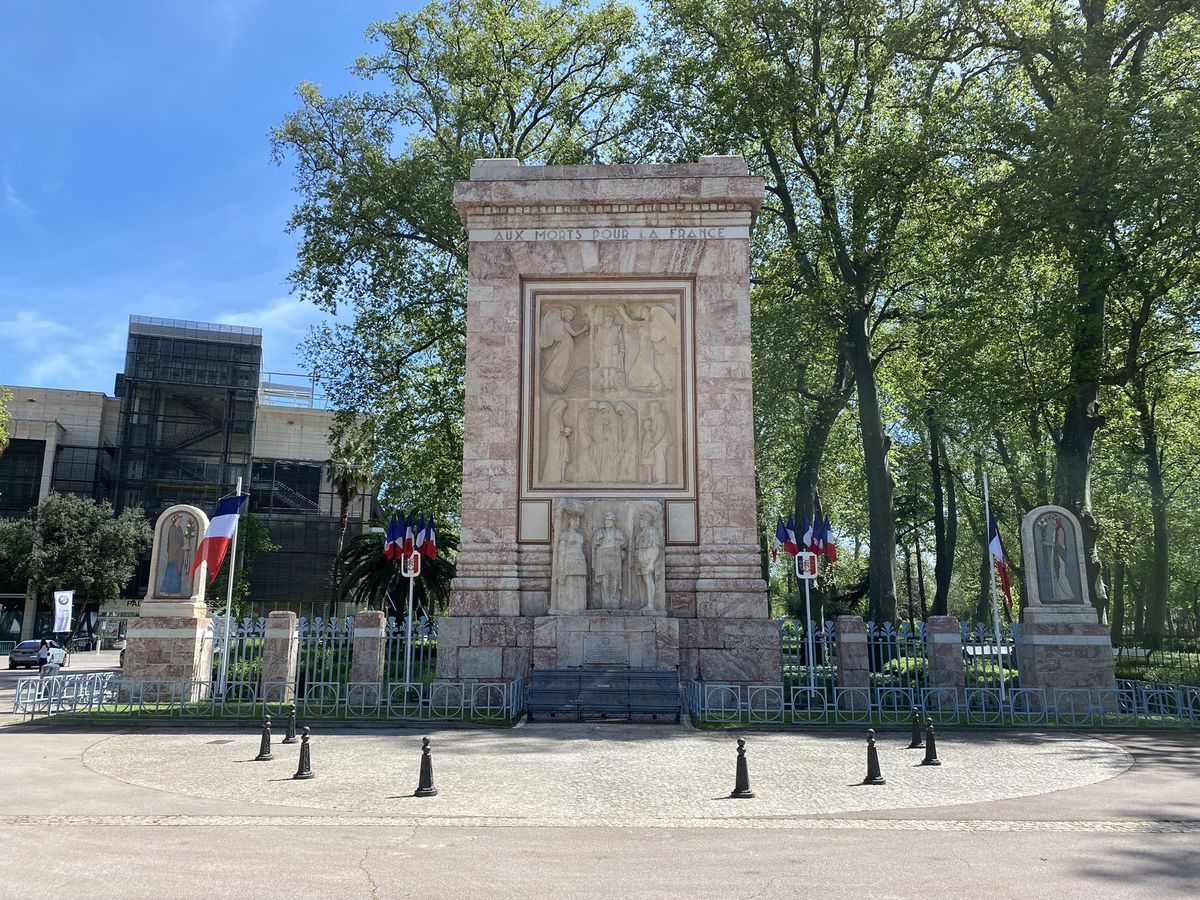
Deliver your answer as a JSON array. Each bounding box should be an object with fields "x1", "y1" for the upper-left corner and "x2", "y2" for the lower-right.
[{"x1": 121, "y1": 616, "x2": 212, "y2": 692}]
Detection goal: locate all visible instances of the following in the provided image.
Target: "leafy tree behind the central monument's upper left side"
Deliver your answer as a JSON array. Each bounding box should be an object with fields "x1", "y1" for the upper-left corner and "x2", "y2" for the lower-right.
[{"x1": 272, "y1": 0, "x2": 635, "y2": 521}]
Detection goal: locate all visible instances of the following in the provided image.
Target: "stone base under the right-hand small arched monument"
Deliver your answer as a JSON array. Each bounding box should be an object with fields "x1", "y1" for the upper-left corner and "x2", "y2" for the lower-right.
[{"x1": 1018, "y1": 604, "x2": 1116, "y2": 696}]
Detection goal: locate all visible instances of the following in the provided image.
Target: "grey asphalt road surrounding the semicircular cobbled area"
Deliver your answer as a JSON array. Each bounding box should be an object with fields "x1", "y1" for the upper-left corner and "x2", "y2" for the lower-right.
[{"x1": 0, "y1": 726, "x2": 1200, "y2": 900}]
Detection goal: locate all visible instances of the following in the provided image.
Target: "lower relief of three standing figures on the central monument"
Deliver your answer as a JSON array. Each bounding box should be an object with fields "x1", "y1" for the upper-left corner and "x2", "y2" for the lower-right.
[{"x1": 550, "y1": 499, "x2": 666, "y2": 616}]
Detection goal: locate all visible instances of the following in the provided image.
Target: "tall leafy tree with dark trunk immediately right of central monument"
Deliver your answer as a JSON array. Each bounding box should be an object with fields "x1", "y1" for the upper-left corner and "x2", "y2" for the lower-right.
[{"x1": 647, "y1": 0, "x2": 979, "y2": 619}]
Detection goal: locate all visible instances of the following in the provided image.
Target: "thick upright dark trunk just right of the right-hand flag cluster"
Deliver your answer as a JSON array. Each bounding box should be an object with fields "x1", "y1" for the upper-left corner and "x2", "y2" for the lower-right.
[{"x1": 846, "y1": 306, "x2": 896, "y2": 622}]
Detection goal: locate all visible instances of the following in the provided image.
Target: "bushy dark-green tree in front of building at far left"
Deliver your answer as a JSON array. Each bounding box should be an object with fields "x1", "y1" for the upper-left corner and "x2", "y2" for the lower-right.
[{"x1": 0, "y1": 493, "x2": 152, "y2": 602}]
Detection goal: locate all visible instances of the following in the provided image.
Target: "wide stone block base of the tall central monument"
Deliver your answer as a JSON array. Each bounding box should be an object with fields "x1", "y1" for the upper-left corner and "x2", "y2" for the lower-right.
[{"x1": 437, "y1": 611, "x2": 780, "y2": 684}]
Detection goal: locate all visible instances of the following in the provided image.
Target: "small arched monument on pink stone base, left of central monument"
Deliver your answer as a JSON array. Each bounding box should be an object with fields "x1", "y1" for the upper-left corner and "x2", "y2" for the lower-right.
[{"x1": 121, "y1": 505, "x2": 212, "y2": 690}]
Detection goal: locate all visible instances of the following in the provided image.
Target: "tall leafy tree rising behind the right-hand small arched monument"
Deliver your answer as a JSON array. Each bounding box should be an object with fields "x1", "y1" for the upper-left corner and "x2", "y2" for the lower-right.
[{"x1": 977, "y1": 0, "x2": 1200, "y2": 600}]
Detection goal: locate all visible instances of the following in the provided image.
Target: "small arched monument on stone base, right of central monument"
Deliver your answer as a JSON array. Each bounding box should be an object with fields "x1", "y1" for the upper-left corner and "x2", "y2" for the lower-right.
[{"x1": 1018, "y1": 506, "x2": 1116, "y2": 695}]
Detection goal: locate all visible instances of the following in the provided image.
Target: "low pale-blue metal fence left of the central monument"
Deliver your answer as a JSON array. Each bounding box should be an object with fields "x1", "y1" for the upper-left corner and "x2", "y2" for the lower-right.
[{"x1": 13, "y1": 672, "x2": 524, "y2": 724}]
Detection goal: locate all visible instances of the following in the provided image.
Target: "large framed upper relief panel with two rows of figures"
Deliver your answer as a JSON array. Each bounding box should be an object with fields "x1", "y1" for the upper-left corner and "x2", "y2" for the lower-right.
[{"x1": 532, "y1": 298, "x2": 684, "y2": 488}]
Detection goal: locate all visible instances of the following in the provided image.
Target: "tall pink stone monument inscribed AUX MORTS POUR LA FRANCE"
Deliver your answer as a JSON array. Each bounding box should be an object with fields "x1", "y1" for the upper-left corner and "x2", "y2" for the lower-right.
[{"x1": 437, "y1": 157, "x2": 780, "y2": 683}]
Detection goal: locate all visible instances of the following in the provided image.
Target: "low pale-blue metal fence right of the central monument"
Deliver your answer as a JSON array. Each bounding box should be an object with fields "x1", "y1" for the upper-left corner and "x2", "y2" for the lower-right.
[{"x1": 688, "y1": 680, "x2": 1200, "y2": 728}]
